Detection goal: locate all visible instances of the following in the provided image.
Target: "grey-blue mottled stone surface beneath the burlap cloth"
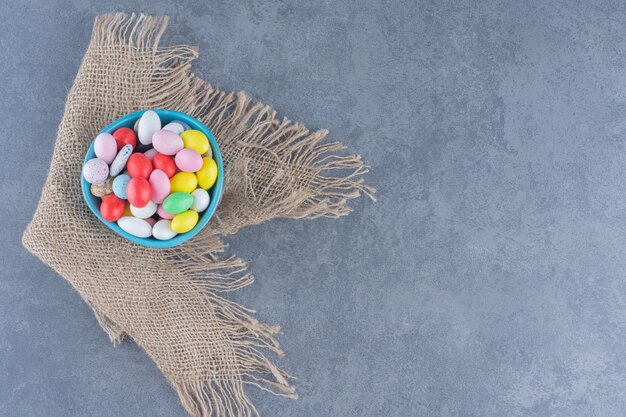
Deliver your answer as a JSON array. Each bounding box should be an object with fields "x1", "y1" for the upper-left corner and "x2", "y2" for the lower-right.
[{"x1": 0, "y1": 0, "x2": 626, "y2": 417}]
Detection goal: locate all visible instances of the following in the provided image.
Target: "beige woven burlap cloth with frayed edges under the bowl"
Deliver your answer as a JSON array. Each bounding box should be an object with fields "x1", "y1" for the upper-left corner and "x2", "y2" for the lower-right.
[{"x1": 23, "y1": 14, "x2": 373, "y2": 416}]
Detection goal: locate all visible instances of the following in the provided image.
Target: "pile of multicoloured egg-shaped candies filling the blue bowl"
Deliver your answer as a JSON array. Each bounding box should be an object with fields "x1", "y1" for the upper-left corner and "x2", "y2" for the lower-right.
[{"x1": 83, "y1": 110, "x2": 218, "y2": 240}]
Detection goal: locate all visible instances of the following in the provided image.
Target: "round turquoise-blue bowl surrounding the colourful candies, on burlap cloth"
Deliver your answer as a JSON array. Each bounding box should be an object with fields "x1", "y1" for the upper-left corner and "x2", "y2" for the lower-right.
[{"x1": 81, "y1": 110, "x2": 224, "y2": 248}]
